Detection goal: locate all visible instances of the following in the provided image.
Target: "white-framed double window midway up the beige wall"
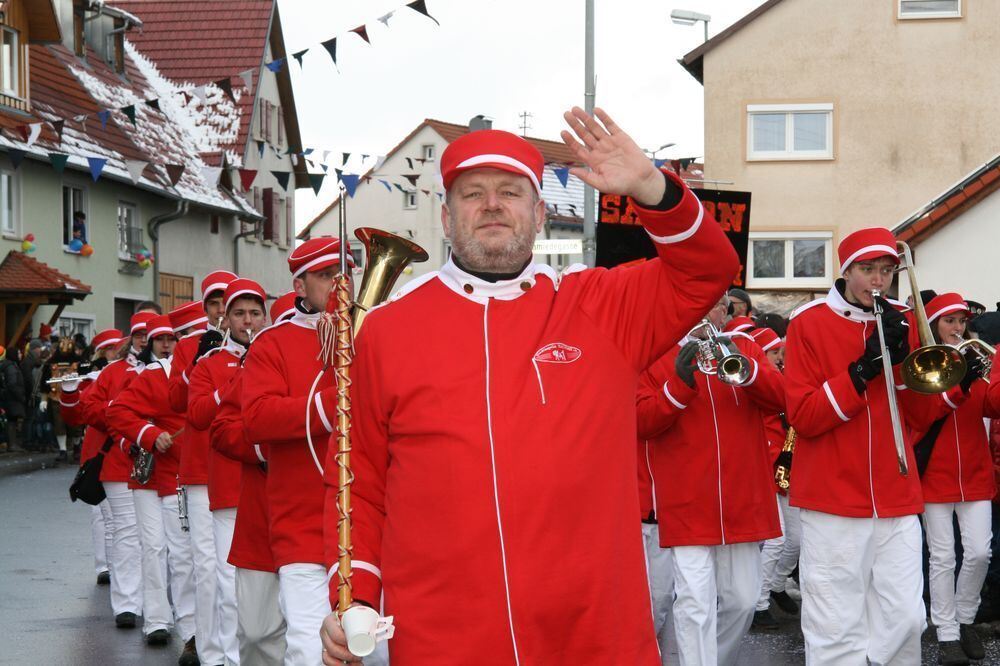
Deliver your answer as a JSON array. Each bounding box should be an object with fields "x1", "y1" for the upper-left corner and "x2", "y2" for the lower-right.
[{"x1": 747, "y1": 104, "x2": 833, "y2": 160}]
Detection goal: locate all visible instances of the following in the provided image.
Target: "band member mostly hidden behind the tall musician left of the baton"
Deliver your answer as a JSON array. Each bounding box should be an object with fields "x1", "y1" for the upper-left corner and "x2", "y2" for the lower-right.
[{"x1": 211, "y1": 292, "x2": 296, "y2": 666}]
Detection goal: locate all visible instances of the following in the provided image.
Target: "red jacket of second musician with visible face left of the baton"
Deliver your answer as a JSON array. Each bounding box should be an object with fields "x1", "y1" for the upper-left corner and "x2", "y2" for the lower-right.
[{"x1": 187, "y1": 341, "x2": 244, "y2": 511}]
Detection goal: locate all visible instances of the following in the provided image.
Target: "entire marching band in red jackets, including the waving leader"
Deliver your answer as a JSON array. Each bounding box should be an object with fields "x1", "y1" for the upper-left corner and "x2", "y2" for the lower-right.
[{"x1": 31, "y1": 109, "x2": 1000, "y2": 666}]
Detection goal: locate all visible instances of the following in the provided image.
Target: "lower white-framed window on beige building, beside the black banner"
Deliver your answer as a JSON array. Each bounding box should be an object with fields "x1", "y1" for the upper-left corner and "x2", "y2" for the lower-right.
[{"x1": 747, "y1": 231, "x2": 833, "y2": 288}]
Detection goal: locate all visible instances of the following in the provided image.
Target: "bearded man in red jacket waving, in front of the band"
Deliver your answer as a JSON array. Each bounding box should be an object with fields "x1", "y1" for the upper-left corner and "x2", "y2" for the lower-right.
[{"x1": 320, "y1": 109, "x2": 744, "y2": 665}]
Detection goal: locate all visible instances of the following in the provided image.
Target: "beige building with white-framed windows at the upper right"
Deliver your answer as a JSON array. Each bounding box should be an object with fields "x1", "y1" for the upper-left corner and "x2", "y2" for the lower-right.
[{"x1": 681, "y1": 0, "x2": 1000, "y2": 311}]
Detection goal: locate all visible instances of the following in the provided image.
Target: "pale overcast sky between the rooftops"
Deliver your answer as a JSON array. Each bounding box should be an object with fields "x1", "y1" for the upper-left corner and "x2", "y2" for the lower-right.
[{"x1": 278, "y1": 0, "x2": 763, "y2": 228}]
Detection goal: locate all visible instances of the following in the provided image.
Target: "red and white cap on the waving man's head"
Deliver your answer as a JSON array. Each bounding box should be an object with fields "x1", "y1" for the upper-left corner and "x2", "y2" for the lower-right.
[{"x1": 441, "y1": 130, "x2": 545, "y2": 193}]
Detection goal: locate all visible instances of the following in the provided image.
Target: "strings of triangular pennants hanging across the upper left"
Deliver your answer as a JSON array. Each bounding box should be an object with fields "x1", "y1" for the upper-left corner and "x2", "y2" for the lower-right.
[{"x1": 0, "y1": 0, "x2": 441, "y2": 193}]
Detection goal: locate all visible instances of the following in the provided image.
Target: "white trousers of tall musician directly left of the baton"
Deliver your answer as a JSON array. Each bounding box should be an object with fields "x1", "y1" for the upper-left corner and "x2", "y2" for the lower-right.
[{"x1": 278, "y1": 563, "x2": 330, "y2": 666}]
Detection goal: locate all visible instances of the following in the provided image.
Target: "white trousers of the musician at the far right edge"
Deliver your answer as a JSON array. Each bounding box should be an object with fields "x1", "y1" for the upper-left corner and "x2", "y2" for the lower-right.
[{"x1": 924, "y1": 500, "x2": 993, "y2": 641}]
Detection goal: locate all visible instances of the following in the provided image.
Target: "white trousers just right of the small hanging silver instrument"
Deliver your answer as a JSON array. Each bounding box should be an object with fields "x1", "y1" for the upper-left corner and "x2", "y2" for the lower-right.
[{"x1": 186, "y1": 484, "x2": 225, "y2": 664}]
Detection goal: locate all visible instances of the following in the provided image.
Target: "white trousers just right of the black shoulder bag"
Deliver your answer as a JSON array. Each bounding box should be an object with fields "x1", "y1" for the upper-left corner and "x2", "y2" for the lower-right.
[{"x1": 104, "y1": 481, "x2": 142, "y2": 615}]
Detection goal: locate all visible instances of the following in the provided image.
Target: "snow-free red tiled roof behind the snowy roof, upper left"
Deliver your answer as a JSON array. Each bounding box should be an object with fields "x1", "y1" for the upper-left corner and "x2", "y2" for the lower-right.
[{"x1": 112, "y1": 0, "x2": 274, "y2": 155}]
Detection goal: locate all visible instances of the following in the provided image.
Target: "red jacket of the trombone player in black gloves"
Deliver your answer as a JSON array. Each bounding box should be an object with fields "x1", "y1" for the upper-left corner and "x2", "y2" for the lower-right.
[{"x1": 785, "y1": 281, "x2": 929, "y2": 518}]
